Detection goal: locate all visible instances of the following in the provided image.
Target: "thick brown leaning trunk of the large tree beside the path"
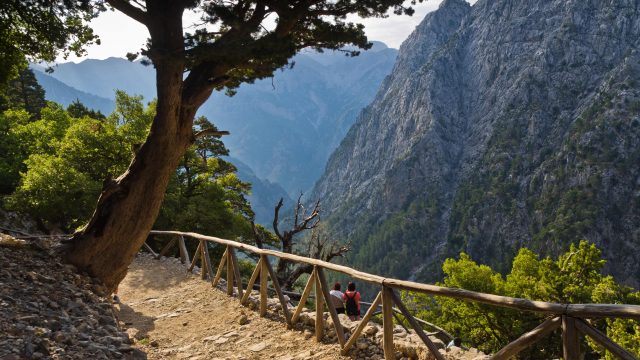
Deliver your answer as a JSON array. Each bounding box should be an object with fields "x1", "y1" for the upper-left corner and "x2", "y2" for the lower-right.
[{"x1": 63, "y1": 9, "x2": 197, "y2": 290}]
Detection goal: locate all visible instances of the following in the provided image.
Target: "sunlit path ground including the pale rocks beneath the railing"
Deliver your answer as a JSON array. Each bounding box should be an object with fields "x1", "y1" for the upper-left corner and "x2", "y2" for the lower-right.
[{"x1": 118, "y1": 254, "x2": 486, "y2": 360}]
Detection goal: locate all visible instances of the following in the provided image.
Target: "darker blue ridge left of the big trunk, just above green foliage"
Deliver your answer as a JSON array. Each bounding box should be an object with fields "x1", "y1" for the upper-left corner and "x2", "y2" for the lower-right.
[{"x1": 33, "y1": 70, "x2": 115, "y2": 115}]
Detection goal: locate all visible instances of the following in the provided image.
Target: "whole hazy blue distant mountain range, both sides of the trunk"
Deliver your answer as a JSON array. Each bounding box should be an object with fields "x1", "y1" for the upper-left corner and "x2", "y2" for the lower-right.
[{"x1": 32, "y1": 42, "x2": 397, "y2": 224}]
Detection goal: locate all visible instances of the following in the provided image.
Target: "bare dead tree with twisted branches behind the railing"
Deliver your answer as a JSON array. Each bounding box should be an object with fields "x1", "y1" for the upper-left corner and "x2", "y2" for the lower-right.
[{"x1": 273, "y1": 194, "x2": 351, "y2": 289}]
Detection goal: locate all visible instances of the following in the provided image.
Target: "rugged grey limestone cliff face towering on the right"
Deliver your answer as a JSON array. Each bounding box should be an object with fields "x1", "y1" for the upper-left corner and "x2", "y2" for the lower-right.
[{"x1": 313, "y1": 0, "x2": 640, "y2": 286}]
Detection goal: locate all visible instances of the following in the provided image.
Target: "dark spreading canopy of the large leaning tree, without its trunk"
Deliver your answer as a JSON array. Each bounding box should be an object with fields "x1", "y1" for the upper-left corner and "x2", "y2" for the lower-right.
[{"x1": 119, "y1": 0, "x2": 422, "y2": 104}]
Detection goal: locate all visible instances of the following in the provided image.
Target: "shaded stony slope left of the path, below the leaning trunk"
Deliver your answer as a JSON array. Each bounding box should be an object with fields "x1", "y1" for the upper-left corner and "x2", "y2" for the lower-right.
[{"x1": 0, "y1": 234, "x2": 146, "y2": 360}]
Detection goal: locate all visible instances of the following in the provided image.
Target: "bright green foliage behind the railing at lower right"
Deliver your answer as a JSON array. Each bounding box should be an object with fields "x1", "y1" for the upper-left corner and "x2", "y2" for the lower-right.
[{"x1": 403, "y1": 241, "x2": 640, "y2": 359}]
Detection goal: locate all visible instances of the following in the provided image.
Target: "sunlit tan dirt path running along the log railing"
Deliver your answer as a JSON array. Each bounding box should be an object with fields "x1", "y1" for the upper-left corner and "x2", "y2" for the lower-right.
[{"x1": 119, "y1": 254, "x2": 347, "y2": 360}]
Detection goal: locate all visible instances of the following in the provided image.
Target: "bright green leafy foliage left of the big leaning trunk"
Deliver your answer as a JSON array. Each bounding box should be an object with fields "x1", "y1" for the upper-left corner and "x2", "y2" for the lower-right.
[{"x1": 7, "y1": 92, "x2": 154, "y2": 230}]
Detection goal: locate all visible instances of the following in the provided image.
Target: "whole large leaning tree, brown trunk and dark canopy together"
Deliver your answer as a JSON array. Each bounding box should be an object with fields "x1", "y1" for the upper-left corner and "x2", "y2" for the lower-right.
[{"x1": 55, "y1": 0, "x2": 422, "y2": 289}]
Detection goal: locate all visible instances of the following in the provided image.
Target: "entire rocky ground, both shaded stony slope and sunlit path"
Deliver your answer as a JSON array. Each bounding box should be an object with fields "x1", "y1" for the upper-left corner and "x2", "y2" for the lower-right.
[{"x1": 0, "y1": 234, "x2": 485, "y2": 360}]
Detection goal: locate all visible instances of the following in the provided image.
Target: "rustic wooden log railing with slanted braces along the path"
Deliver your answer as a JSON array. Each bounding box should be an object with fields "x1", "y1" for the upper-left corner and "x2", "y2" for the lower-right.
[{"x1": 148, "y1": 231, "x2": 640, "y2": 360}]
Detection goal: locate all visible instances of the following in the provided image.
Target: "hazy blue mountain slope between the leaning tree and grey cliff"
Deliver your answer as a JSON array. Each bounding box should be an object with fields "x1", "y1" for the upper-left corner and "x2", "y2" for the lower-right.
[{"x1": 201, "y1": 43, "x2": 397, "y2": 197}]
